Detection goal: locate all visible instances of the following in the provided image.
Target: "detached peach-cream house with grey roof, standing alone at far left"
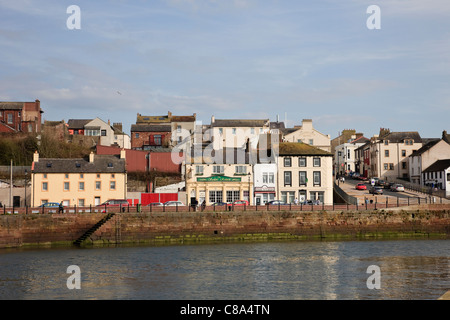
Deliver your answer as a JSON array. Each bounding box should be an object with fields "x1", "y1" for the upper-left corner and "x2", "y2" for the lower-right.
[{"x1": 31, "y1": 150, "x2": 127, "y2": 207}]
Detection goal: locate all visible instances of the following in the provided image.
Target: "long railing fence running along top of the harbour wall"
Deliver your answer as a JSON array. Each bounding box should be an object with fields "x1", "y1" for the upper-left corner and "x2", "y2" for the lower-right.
[{"x1": 0, "y1": 197, "x2": 442, "y2": 214}]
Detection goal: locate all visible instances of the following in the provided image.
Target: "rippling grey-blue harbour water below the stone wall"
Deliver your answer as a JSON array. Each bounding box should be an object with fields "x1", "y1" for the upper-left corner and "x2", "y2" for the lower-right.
[{"x1": 0, "y1": 240, "x2": 450, "y2": 300}]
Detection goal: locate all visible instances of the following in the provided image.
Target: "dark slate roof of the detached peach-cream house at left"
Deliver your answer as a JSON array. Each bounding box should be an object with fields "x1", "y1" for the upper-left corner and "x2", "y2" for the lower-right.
[{"x1": 31, "y1": 154, "x2": 126, "y2": 173}]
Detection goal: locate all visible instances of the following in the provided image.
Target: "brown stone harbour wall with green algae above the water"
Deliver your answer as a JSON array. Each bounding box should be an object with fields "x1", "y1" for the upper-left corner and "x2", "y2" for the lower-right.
[{"x1": 0, "y1": 205, "x2": 450, "y2": 248}]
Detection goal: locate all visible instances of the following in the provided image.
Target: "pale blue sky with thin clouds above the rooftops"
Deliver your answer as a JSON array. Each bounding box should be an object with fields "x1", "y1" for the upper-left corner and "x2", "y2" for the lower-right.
[{"x1": 0, "y1": 0, "x2": 450, "y2": 138}]
